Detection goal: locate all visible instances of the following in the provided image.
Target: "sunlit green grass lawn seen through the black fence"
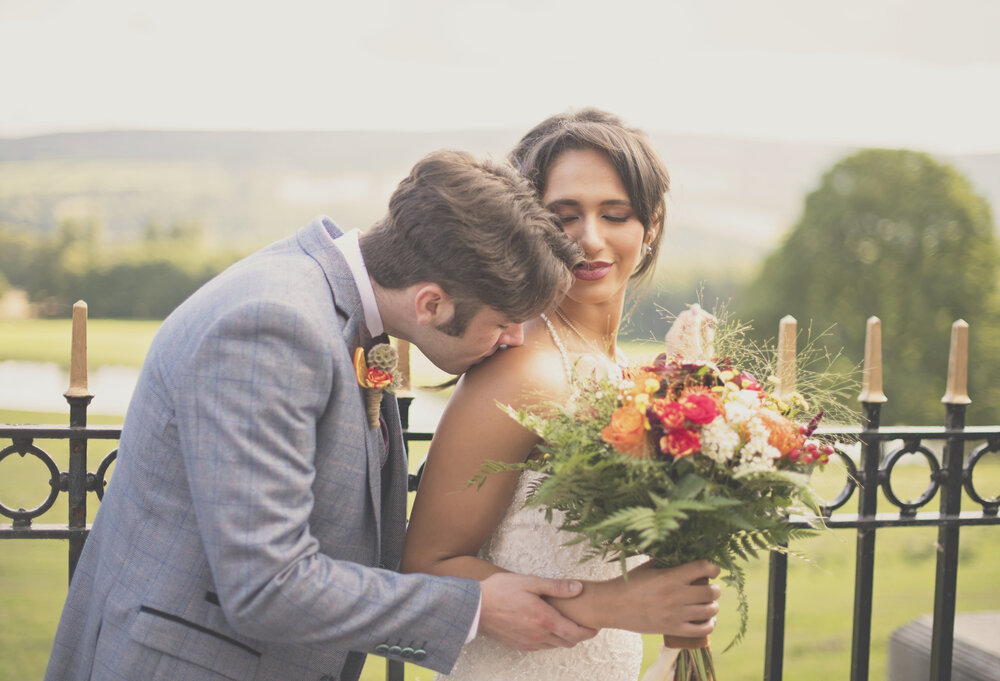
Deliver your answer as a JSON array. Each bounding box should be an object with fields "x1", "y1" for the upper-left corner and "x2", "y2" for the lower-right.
[{"x1": 0, "y1": 320, "x2": 1000, "y2": 681}]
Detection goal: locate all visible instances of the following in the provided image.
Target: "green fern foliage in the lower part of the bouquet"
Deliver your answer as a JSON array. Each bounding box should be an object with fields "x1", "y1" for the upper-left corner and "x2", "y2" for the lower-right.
[{"x1": 508, "y1": 380, "x2": 828, "y2": 645}]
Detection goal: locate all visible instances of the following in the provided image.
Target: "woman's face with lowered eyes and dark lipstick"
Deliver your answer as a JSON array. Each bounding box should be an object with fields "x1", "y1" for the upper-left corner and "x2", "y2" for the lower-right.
[{"x1": 542, "y1": 149, "x2": 652, "y2": 303}]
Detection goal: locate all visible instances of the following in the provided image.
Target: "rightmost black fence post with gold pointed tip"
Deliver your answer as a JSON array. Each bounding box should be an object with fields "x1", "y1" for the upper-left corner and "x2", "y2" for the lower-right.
[{"x1": 930, "y1": 319, "x2": 971, "y2": 681}]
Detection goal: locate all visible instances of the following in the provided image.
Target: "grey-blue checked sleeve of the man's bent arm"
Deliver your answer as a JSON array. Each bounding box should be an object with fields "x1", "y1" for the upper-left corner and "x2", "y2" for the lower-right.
[{"x1": 166, "y1": 301, "x2": 479, "y2": 671}]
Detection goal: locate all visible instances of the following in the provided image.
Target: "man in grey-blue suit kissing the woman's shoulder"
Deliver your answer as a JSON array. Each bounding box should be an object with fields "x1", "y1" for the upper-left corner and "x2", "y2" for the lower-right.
[{"x1": 45, "y1": 152, "x2": 594, "y2": 681}]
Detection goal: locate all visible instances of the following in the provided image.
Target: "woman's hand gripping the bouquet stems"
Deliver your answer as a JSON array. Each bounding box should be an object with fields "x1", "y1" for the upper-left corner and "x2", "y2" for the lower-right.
[{"x1": 606, "y1": 560, "x2": 721, "y2": 638}]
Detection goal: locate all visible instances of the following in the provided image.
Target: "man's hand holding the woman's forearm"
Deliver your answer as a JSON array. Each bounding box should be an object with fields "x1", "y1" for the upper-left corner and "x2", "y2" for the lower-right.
[{"x1": 479, "y1": 572, "x2": 597, "y2": 650}]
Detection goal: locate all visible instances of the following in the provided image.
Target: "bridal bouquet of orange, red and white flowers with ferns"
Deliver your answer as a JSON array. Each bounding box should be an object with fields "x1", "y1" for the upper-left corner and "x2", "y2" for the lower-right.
[{"x1": 497, "y1": 309, "x2": 833, "y2": 680}]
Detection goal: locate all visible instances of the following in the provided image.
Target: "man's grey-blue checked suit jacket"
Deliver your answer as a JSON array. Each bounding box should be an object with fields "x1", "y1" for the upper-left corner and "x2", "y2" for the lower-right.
[{"x1": 45, "y1": 217, "x2": 479, "y2": 681}]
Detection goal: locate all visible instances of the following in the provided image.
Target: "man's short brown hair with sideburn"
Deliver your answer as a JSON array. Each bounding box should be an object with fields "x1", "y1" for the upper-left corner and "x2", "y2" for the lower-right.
[{"x1": 361, "y1": 150, "x2": 583, "y2": 336}]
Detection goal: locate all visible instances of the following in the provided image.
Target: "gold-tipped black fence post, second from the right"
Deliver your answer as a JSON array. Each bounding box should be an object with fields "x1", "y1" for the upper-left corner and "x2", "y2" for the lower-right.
[{"x1": 851, "y1": 317, "x2": 886, "y2": 681}]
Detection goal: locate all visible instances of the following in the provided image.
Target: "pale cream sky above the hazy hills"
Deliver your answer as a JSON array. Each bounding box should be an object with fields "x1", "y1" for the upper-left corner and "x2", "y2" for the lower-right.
[{"x1": 0, "y1": 0, "x2": 1000, "y2": 153}]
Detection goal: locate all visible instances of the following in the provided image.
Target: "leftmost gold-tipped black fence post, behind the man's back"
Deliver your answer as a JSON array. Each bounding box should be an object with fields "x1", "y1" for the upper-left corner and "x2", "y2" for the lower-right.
[{"x1": 59, "y1": 300, "x2": 94, "y2": 581}]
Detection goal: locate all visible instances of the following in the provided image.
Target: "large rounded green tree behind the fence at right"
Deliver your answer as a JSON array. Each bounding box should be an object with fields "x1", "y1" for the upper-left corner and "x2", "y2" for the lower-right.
[{"x1": 740, "y1": 149, "x2": 1000, "y2": 423}]
